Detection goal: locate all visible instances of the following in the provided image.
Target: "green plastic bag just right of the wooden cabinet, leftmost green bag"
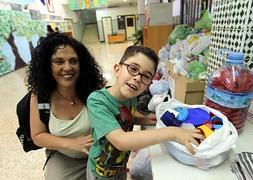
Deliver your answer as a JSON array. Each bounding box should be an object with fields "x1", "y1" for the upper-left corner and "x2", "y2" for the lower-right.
[{"x1": 168, "y1": 24, "x2": 193, "y2": 45}]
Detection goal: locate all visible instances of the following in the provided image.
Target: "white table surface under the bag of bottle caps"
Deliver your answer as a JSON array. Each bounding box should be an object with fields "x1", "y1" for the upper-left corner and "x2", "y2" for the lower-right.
[{"x1": 149, "y1": 121, "x2": 253, "y2": 180}]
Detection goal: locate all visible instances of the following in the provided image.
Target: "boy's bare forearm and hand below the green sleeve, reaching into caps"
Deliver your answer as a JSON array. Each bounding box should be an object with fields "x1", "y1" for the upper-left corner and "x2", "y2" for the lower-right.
[{"x1": 106, "y1": 127, "x2": 204, "y2": 153}]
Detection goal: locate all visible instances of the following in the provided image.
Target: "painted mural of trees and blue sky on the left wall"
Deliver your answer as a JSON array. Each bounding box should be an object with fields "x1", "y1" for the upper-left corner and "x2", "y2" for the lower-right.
[{"x1": 0, "y1": 10, "x2": 46, "y2": 76}]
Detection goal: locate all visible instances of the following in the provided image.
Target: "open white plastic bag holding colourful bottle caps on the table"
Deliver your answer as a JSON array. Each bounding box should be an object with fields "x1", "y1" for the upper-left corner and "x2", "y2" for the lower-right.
[{"x1": 156, "y1": 99, "x2": 238, "y2": 170}]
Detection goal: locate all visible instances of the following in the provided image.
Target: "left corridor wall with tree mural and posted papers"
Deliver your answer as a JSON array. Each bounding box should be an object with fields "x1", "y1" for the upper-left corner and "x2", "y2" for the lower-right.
[{"x1": 0, "y1": 0, "x2": 85, "y2": 76}]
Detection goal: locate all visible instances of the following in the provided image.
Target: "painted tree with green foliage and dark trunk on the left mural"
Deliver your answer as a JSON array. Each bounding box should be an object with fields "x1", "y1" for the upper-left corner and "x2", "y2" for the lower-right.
[{"x1": 0, "y1": 10, "x2": 46, "y2": 69}]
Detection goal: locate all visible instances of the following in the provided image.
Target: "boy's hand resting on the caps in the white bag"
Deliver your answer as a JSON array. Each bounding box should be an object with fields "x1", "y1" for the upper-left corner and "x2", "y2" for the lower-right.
[{"x1": 170, "y1": 127, "x2": 204, "y2": 154}]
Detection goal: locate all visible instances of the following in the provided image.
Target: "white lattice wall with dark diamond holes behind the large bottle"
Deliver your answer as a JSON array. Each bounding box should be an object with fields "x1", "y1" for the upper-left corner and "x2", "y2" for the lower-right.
[{"x1": 207, "y1": 0, "x2": 253, "y2": 74}]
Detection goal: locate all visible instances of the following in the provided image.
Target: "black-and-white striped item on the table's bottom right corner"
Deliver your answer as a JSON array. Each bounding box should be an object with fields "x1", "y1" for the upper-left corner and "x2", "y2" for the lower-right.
[{"x1": 231, "y1": 152, "x2": 253, "y2": 180}]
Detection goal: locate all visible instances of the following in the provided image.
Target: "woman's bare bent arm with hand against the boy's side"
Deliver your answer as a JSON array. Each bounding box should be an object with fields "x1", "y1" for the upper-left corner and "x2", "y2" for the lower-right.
[{"x1": 30, "y1": 94, "x2": 93, "y2": 152}]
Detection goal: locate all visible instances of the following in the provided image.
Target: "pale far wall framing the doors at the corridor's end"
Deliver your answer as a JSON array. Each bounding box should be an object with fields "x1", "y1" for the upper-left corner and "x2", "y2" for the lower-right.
[{"x1": 96, "y1": 6, "x2": 137, "y2": 41}]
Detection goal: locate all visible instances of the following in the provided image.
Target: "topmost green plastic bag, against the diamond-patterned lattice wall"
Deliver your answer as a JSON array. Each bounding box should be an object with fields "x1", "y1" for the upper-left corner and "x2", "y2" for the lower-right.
[{"x1": 194, "y1": 10, "x2": 213, "y2": 31}]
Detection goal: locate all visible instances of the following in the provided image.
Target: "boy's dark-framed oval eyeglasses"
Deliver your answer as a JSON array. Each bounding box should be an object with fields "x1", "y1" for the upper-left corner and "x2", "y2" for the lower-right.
[{"x1": 120, "y1": 63, "x2": 152, "y2": 85}]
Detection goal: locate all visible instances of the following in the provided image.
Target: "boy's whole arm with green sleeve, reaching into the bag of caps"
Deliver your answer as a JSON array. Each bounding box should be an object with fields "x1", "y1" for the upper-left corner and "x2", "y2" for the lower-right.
[{"x1": 87, "y1": 93, "x2": 204, "y2": 153}]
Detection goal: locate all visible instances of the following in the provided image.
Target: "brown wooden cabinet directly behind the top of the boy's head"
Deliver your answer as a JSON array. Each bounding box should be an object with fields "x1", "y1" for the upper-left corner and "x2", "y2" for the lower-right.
[{"x1": 143, "y1": 25, "x2": 173, "y2": 53}]
